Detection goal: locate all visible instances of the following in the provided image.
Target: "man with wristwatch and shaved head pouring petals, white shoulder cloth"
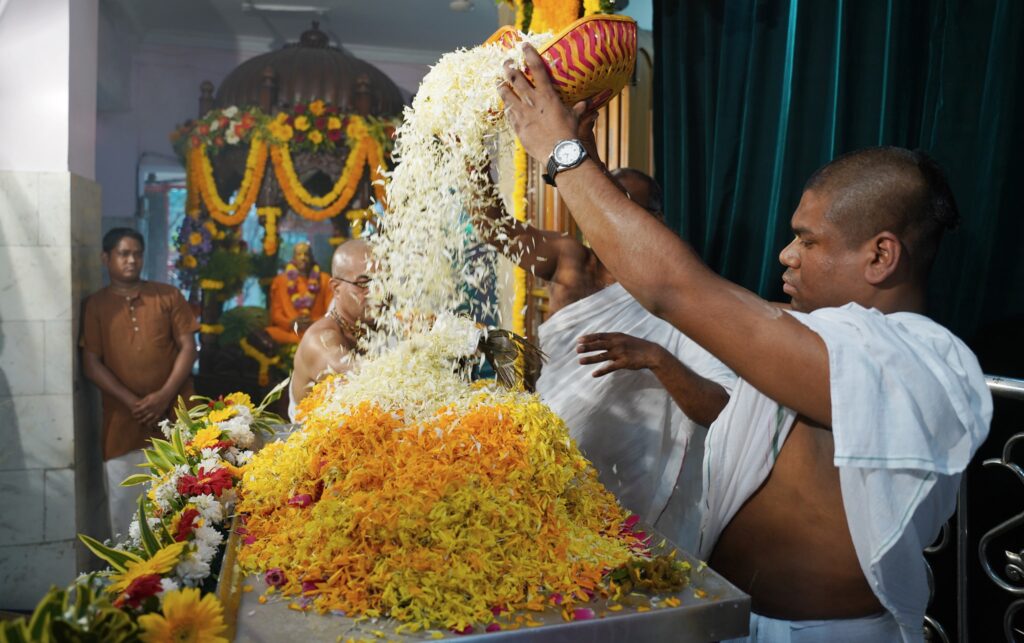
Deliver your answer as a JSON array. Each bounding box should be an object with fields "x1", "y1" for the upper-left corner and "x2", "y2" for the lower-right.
[{"x1": 499, "y1": 46, "x2": 992, "y2": 643}]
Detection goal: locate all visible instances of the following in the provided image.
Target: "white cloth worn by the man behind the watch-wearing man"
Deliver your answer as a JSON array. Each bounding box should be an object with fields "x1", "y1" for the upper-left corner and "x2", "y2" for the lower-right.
[{"x1": 537, "y1": 284, "x2": 735, "y2": 551}]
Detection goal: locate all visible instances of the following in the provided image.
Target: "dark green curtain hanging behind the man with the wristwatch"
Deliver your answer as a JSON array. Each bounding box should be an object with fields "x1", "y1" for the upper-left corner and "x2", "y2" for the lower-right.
[{"x1": 654, "y1": 0, "x2": 1024, "y2": 338}]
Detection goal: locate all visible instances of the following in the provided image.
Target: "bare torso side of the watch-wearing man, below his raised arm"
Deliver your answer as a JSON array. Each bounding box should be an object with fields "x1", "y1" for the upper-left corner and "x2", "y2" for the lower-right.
[{"x1": 709, "y1": 417, "x2": 883, "y2": 619}]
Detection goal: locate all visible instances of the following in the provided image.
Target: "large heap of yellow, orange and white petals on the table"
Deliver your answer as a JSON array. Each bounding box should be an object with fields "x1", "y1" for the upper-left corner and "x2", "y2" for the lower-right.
[{"x1": 238, "y1": 317, "x2": 644, "y2": 632}]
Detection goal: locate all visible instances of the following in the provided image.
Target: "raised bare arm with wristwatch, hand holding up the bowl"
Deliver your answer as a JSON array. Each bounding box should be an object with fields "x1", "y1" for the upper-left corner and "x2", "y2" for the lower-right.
[{"x1": 499, "y1": 45, "x2": 831, "y2": 426}]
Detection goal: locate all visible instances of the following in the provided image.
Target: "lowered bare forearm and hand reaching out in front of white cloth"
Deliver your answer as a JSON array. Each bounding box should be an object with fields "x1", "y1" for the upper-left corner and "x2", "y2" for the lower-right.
[{"x1": 577, "y1": 333, "x2": 729, "y2": 426}]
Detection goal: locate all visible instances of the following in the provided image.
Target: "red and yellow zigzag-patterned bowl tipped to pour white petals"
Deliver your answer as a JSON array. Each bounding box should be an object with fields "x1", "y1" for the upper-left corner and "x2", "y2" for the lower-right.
[{"x1": 487, "y1": 15, "x2": 637, "y2": 109}]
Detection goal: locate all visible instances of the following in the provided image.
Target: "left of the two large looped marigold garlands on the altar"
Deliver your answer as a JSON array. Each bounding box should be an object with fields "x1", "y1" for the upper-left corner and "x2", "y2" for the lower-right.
[{"x1": 187, "y1": 137, "x2": 267, "y2": 226}]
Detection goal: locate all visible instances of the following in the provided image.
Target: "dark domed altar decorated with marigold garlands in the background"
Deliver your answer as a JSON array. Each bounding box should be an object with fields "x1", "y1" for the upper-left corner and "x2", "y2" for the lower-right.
[{"x1": 171, "y1": 23, "x2": 403, "y2": 407}]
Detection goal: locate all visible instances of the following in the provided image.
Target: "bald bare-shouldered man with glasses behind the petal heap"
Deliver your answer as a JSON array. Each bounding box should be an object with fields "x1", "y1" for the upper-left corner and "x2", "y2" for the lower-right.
[{"x1": 288, "y1": 240, "x2": 372, "y2": 422}]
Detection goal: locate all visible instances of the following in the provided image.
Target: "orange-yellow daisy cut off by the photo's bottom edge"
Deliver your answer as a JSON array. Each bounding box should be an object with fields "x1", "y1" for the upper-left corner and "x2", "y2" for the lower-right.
[{"x1": 138, "y1": 588, "x2": 227, "y2": 643}]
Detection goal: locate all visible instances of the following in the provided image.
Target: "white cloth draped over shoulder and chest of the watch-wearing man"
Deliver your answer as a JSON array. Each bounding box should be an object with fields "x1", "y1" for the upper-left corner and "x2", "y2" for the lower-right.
[{"x1": 697, "y1": 304, "x2": 992, "y2": 641}]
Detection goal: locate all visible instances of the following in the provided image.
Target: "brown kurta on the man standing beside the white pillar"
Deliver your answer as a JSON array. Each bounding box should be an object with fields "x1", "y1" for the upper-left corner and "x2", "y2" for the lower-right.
[{"x1": 79, "y1": 282, "x2": 199, "y2": 460}]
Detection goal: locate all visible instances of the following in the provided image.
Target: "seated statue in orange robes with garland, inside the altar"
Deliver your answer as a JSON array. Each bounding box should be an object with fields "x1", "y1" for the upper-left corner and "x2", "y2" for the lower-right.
[{"x1": 266, "y1": 242, "x2": 331, "y2": 344}]
